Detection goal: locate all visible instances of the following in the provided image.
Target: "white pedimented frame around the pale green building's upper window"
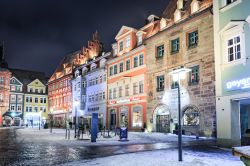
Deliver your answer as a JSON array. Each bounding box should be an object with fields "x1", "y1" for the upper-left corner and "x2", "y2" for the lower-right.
[{"x1": 220, "y1": 21, "x2": 246, "y2": 65}]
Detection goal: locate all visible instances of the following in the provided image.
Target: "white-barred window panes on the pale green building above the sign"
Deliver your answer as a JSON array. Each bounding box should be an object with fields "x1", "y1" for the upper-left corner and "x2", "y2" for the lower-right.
[{"x1": 227, "y1": 36, "x2": 241, "y2": 62}]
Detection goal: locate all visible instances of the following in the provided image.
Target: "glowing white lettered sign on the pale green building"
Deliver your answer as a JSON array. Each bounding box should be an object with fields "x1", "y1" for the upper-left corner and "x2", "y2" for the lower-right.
[{"x1": 226, "y1": 77, "x2": 250, "y2": 90}]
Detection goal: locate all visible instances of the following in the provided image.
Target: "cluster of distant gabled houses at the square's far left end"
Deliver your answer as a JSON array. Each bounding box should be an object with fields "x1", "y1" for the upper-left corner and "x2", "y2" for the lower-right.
[{"x1": 0, "y1": 52, "x2": 48, "y2": 127}]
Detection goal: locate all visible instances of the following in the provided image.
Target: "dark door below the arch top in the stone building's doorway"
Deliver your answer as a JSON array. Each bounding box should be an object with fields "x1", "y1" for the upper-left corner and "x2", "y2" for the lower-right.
[{"x1": 156, "y1": 115, "x2": 170, "y2": 133}]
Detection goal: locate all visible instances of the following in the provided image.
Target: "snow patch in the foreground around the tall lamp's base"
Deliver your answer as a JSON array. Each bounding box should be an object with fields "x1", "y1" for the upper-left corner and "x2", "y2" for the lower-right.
[{"x1": 61, "y1": 150, "x2": 244, "y2": 166}]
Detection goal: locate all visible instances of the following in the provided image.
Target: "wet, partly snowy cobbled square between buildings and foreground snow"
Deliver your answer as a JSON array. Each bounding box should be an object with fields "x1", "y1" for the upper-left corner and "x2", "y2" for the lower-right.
[{"x1": 0, "y1": 128, "x2": 242, "y2": 166}]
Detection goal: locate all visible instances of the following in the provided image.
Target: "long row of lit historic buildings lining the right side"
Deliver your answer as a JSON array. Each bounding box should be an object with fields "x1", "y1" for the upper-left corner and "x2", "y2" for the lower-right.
[{"x1": 0, "y1": 0, "x2": 250, "y2": 146}]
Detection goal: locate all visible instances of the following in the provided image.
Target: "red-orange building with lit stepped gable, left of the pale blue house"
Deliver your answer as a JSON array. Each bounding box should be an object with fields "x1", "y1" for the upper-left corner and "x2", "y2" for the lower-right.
[{"x1": 48, "y1": 32, "x2": 102, "y2": 127}]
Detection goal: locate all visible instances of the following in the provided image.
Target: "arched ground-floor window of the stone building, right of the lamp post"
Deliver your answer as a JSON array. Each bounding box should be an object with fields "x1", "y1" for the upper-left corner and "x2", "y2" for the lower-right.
[{"x1": 183, "y1": 106, "x2": 200, "y2": 126}]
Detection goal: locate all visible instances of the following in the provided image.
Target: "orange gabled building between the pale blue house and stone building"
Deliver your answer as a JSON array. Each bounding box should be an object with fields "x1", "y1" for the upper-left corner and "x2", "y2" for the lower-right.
[{"x1": 106, "y1": 16, "x2": 159, "y2": 131}]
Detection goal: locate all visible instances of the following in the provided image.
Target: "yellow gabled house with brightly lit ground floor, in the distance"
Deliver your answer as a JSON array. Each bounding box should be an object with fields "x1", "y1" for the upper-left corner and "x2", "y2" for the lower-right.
[{"x1": 24, "y1": 79, "x2": 48, "y2": 127}]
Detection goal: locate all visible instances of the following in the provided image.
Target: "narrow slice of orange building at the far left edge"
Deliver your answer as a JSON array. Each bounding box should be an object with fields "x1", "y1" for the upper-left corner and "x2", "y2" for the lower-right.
[{"x1": 0, "y1": 68, "x2": 11, "y2": 126}]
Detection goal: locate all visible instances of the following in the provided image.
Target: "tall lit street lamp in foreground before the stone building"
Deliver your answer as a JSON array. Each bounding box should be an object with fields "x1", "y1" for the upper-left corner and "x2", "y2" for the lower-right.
[{"x1": 169, "y1": 66, "x2": 191, "y2": 161}]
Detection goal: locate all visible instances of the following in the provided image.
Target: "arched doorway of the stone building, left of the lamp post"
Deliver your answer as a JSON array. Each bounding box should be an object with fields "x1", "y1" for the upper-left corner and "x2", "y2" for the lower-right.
[{"x1": 153, "y1": 105, "x2": 170, "y2": 133}]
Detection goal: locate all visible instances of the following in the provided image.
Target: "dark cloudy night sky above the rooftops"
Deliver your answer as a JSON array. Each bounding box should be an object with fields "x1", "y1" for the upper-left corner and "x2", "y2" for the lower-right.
[{"x1": 0, "y1": 0, "x2": 169, "y2": 76}]
